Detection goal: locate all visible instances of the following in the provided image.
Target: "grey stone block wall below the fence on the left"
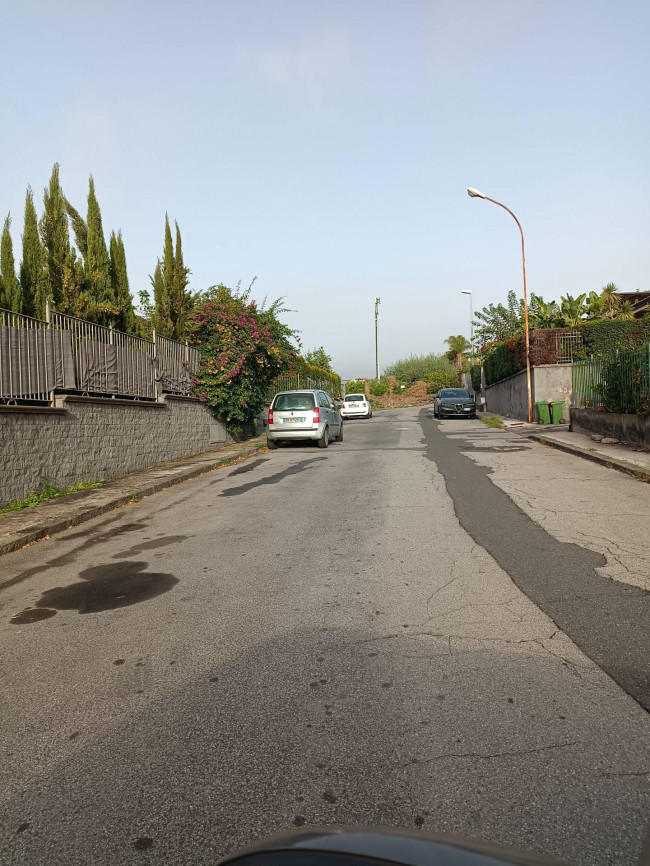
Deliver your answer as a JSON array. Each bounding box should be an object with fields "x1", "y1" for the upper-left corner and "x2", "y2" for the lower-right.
[{"x1": 0, "y1": 396, "x2": 228, "y2": 506}]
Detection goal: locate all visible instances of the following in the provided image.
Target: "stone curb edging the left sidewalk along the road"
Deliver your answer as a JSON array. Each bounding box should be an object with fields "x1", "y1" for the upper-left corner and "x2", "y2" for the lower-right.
[{"x1": 0, "y1": 443, "x2": 260, "y2": 556}]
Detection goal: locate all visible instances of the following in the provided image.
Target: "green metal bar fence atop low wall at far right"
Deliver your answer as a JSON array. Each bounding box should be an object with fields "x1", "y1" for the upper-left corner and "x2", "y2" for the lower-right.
[{"x1": 572, "y1": 343, "x2": 650, "y2": 413}]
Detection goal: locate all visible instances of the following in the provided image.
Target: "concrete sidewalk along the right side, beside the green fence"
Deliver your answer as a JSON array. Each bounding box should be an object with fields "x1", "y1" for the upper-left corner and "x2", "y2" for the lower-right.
[{"x1": 494, "y1": 418, "x2": 650, "y2": 480}]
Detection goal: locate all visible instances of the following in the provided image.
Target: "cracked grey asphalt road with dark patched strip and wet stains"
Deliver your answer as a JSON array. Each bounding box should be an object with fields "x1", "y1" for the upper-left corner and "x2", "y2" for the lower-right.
[{"x1": 0, "y1": 410, "x2": 650, "y2": 864}]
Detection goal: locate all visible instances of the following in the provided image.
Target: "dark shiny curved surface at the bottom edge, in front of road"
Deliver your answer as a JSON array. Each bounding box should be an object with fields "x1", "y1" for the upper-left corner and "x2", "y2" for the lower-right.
[{"x1": 216, "y1": 827, "x2": 562, "y2": 866}]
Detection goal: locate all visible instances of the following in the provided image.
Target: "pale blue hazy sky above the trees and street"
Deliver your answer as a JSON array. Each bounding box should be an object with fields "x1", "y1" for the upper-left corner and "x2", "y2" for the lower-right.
[{"x1": 0, "y1": 0, "x2": 650, "y2": 377}]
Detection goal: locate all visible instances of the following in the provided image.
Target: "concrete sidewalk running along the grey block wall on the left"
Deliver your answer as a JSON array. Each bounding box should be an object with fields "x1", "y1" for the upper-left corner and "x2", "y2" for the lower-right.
[{"x1": 0, "y1": 436, "x2": 266, "y2": 556}]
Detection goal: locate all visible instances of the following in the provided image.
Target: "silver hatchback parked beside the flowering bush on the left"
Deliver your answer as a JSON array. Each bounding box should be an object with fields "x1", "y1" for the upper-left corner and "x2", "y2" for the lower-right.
[{"x1": 266, "y1": 391, "x2": 343, "y2": 448}]
